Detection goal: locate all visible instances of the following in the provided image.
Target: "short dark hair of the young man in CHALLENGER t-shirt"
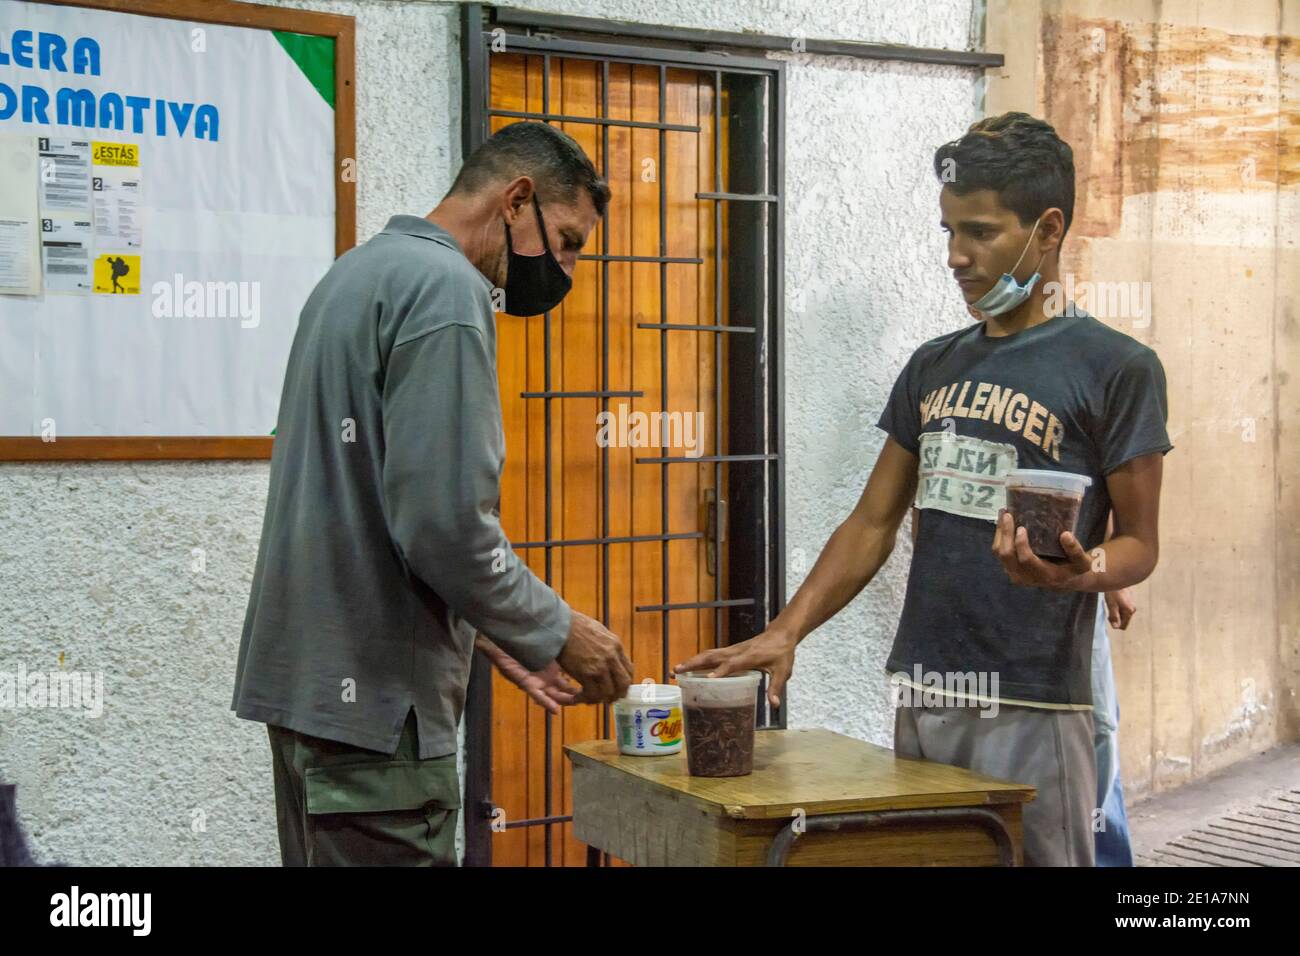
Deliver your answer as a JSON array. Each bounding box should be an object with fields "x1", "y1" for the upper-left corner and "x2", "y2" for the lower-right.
[{"x1": 935, "y1": 113, "x2": 1074, "y2": 234}]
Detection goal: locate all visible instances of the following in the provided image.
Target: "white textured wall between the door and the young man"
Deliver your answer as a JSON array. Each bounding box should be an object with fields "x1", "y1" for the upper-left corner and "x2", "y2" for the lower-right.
[{"x1": 769, "y1": 48, "x2": 975, "y2": 747}]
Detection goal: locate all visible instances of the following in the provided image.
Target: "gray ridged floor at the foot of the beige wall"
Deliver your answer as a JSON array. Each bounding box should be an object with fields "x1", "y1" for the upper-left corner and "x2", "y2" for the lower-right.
[{"x1": 1128, "y1": 744, "x2": 1300, "y2": 866}]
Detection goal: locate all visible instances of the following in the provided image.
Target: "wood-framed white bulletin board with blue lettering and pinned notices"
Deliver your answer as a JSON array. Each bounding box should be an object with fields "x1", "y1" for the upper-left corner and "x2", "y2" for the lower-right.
[{"x1": 0, "y1": 0, "x2": 356, "y2": 460}]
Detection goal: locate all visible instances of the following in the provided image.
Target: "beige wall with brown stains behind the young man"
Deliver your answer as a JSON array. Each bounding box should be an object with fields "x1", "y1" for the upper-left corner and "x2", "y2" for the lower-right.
[{"x1": 985, "y1": 0, "x2": 1300, "y2": 796}]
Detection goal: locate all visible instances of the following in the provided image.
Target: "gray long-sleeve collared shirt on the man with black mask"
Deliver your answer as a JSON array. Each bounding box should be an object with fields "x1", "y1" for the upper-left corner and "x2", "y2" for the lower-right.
[{"x1": 231, "y1": 216, "x2": 571, "y2": 760}]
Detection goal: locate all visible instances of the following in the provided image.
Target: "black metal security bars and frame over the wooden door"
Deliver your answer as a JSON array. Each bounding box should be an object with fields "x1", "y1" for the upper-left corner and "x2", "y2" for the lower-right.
[{"x1": 462, "y1": 4, "x2": 784, "y2": 865}]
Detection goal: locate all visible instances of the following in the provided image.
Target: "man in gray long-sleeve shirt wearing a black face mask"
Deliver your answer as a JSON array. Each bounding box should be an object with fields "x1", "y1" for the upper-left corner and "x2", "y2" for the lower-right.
[{"x1": 239, "y1": 122, "x2": 632, "y2": 865}]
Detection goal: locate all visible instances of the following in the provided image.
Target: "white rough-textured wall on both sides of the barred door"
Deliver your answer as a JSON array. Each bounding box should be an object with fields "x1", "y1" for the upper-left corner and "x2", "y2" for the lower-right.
[{"x1": 0, "y1": 0, "x2": 978, "y2": 865}]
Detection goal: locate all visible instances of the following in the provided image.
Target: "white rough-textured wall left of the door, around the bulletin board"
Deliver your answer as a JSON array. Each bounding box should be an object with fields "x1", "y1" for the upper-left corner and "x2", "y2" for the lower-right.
[{"x1": 0, "y1": 1, "x2": 460, "y2": 865}]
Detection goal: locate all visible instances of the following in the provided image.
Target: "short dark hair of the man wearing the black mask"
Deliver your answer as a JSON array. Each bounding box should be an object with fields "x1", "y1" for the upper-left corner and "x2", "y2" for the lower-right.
[{"x1": 449, "y1": 121, "x2": 610, "y2": 216}]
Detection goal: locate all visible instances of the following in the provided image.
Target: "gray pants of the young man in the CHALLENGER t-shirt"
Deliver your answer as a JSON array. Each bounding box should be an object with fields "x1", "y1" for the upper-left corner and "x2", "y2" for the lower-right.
[{"x1": 894, "y1": 704, "x2": 1097, "y2": 866}]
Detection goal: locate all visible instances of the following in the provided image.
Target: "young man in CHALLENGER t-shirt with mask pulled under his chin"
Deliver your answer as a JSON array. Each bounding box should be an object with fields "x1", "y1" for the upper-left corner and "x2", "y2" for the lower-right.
[{"x1": 677, "y1": 113, "x2": 1173, "y2": 866}]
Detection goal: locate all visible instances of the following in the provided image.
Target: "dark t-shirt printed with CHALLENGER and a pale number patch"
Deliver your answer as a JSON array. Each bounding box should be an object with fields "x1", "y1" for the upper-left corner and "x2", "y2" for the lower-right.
[{"x1": 878, "y1": 312, "x2": 1173, "y2": 705}]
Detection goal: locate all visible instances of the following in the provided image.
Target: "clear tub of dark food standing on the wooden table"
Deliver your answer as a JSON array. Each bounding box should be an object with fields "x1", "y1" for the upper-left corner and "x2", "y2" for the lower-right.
[{"x1": 677, "y1": 671, "x2": 762, "y2": 777}]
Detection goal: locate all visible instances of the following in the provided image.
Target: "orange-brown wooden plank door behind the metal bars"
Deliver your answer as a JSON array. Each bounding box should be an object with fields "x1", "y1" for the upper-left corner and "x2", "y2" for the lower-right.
[{"x1": 488, "y1": 53, "x2": 748, "y2": 865}]
